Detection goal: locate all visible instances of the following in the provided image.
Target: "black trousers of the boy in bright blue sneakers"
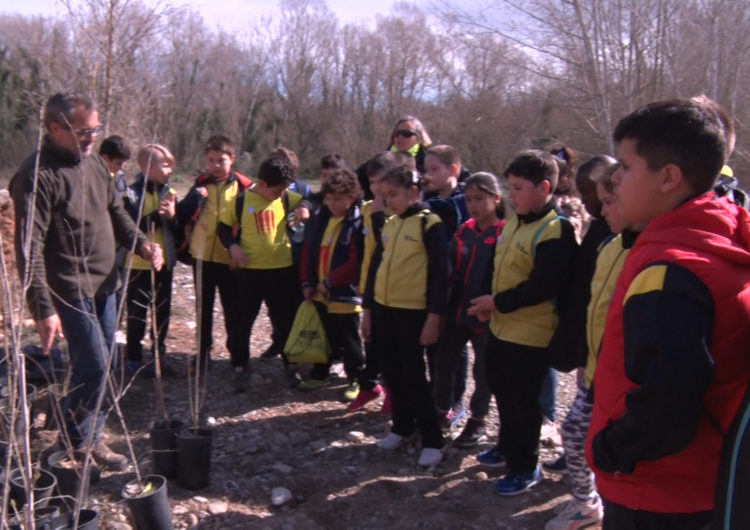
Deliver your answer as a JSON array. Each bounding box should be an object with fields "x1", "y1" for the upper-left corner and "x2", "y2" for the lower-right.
[{"x1": 485, "y1": 333, "x2": 549, "y2": 473}]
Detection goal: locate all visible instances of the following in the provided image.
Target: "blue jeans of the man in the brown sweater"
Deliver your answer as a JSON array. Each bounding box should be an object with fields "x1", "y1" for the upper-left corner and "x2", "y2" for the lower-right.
[{"x1": 55, "y1": 294, "x2": 116, "y2": 448}]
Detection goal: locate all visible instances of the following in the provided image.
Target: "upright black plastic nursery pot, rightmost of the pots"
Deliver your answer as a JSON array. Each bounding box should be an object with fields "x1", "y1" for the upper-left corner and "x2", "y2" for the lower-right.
[{"x1": 175, "y1": 427, "x2": 213, "y2": 490}]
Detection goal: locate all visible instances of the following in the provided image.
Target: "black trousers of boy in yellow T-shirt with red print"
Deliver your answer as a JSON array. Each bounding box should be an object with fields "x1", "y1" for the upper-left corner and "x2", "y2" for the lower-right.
[{"x1": 228, "y1": 267, "x2": 302, "y2": 367}]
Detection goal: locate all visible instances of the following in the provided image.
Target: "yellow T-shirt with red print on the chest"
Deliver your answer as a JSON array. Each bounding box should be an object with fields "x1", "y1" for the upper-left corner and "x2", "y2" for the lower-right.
[{"x1": 219, "y1": 188, "x2": 302, "y2": 269}]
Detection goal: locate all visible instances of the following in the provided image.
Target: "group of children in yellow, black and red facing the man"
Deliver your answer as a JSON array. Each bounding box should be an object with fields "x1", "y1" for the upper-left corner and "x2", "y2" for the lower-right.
[{"x1": 106, "y1": 98, "x2": 750, "y2": 529}]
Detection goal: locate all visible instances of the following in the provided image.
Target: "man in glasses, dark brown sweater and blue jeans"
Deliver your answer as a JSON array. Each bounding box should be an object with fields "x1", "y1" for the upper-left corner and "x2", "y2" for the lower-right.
[{"x1": 9, "y1": 94, "x2": 163, "y2": 469}]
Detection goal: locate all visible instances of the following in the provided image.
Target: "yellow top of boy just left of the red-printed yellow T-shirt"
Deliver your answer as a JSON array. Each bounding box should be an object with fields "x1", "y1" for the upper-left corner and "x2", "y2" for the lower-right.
[{"x1": 190, "y1": 180, "x2": 244, "y2": 265}]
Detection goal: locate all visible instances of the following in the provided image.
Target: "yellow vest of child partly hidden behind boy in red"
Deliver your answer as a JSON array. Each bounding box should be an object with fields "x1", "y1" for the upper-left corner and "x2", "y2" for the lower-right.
[{"x1": 586, "y1": 235, "x2": 630, "y2": 388}]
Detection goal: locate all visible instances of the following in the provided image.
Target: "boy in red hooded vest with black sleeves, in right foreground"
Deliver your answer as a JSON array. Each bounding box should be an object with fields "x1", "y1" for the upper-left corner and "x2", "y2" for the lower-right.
[{"x1": 587, "y1": 100, "x2": 750, "y2": 529}]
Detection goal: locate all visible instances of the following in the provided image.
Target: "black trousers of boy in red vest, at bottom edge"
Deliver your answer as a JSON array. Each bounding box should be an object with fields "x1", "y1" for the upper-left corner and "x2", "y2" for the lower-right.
[{"x1": 602, "y1": 499, "x2": 713, "y2": 530}]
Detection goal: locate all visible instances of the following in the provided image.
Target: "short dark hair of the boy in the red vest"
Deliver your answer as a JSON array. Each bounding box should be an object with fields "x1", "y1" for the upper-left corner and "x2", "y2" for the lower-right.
[{"x1": 613, "y1": 99, "x2": 728, "y2": 193}]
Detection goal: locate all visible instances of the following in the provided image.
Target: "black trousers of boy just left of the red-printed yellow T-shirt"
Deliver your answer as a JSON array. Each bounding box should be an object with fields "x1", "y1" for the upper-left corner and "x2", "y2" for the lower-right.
[{"x1": 193, "y1": 260, "x2": 238, "y2": 364}]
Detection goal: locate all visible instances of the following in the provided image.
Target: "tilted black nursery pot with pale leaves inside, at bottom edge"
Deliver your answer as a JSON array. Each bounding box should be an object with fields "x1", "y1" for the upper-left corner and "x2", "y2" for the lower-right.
[{"x1": 122, "y1": 475, "x2": 172, "y2": 530}]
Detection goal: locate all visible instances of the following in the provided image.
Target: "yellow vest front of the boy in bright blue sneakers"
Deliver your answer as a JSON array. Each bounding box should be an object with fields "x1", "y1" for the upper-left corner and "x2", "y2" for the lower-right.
[{"x1": 490, "y1": 210, "x2": 562, "y2": 348}]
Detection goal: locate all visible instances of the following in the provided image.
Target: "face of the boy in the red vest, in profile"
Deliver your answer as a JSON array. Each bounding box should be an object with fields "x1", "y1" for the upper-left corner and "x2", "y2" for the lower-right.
[{"x1": 612, "y1": 138, "x2": 671, "y2": 226}]
